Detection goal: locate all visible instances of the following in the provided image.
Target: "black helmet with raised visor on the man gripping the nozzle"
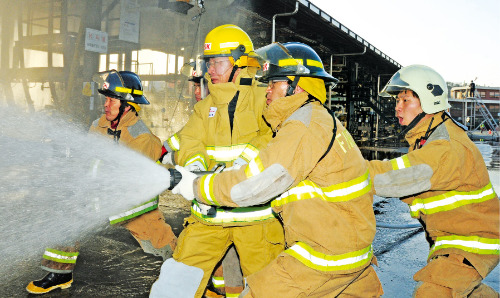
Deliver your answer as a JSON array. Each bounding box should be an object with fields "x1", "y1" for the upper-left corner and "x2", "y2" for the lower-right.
[{"x1": 255, "y1": 42, "x2": 338, "y2": 83}]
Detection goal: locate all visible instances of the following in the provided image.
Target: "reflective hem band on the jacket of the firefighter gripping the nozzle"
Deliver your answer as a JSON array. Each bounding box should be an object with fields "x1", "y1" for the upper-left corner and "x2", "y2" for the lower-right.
[{"x1": 285, "y1": 242, "x2": 373, "y2": 271}]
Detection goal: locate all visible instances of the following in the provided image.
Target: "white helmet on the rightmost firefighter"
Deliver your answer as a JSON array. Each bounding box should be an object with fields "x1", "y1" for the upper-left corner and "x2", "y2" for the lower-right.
[{"x1": 379, "y1": 64, "x2": 450, "y2": 114}]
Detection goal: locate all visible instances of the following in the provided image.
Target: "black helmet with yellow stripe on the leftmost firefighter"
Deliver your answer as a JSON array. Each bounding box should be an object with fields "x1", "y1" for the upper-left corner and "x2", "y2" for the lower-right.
[{"x1": 92, "y1": 69, "x2": 149, "y2": 105}]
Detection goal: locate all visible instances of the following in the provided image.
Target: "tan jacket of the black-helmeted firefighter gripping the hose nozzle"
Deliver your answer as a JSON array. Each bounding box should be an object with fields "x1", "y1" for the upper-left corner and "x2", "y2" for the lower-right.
[{"x1": 194, "y1": 92, "x2": 375, "y2": 274}]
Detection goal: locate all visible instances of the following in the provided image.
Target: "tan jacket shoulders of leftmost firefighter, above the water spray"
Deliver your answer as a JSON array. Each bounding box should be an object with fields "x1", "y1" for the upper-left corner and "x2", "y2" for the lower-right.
[{"x1": 90, "y1": 112, "x2": 162, "y2": 161}]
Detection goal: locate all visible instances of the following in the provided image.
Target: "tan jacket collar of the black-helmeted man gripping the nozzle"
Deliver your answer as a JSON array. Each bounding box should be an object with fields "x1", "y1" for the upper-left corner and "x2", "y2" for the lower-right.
[{"x1": 262, "y1": 92, "x2": 309, "y2": 131}]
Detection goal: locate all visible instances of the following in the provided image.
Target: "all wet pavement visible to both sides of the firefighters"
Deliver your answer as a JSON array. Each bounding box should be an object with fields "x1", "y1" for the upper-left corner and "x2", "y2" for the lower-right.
[{"x1": 0, "y1": 171, "x2": 500, "y2": 297}]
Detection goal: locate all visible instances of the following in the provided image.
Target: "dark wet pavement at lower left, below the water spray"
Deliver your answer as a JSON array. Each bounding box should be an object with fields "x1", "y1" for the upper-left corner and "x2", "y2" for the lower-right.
[{"x1": 0, "y1": 192, "x2": 189, "y2": 297}]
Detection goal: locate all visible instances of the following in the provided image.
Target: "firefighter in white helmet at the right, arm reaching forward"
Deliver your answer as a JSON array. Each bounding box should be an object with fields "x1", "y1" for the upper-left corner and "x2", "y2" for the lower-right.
[{"x1": 369, "y1": 65, "x2": 500, "y2": 297}]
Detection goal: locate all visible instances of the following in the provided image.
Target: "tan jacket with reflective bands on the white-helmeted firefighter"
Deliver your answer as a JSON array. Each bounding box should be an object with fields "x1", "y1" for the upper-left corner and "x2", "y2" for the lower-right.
[{"x1": 368, "y1": 112, "x2": 500, "y2": 278}]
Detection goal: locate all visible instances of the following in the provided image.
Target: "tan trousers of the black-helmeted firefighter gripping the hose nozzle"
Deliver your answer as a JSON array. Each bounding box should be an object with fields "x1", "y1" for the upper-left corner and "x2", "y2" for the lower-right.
[{"x1": 244, "y1": 253, "x2": 384, "y2": 298}]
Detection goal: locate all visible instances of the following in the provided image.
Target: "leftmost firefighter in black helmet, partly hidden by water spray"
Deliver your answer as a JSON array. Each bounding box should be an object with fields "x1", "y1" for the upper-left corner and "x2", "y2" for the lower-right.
[{"x1": 26, "y1": 70, "x2": 177, "y2": 294}]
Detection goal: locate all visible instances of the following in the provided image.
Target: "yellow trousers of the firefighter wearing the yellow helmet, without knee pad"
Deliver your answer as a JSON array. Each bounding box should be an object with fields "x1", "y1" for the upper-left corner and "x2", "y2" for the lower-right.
[{"x1": 173, "y1": 216, "x2": 284, "y2": 297}]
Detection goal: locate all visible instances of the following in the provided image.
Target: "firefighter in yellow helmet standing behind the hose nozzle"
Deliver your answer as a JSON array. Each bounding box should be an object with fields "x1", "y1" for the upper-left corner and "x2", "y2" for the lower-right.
[{"x1": 151, "y1": 25, "x2": 284, "y2": 297}]
